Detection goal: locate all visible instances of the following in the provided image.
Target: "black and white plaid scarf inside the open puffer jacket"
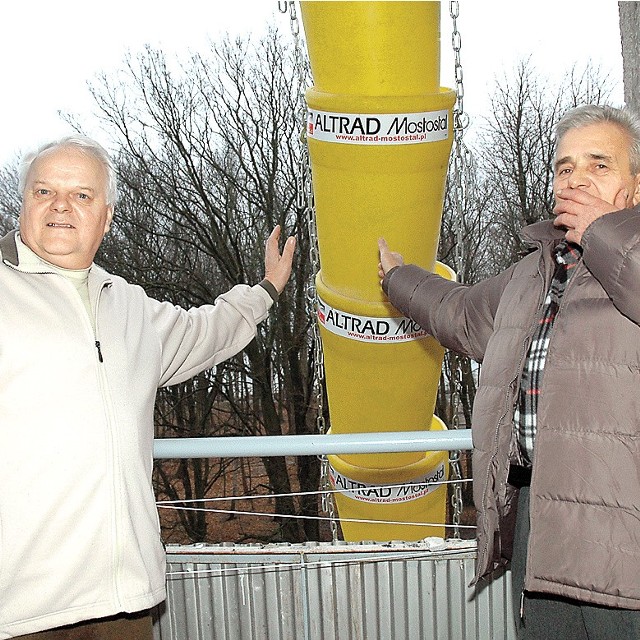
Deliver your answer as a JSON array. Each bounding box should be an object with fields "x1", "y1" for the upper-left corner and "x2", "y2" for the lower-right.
[{"x1": 513, "y1": 241, "x2": 582, "y2": 465}]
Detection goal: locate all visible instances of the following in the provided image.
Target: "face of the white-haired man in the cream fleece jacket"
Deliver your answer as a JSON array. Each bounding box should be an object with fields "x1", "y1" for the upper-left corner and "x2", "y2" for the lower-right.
[{"x1": 20, "y1": 146, "x2": 113, "y2": 269}]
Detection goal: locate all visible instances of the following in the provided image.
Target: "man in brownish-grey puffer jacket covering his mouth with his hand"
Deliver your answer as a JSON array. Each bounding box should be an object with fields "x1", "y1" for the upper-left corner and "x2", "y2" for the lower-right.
[{"x1": 379, "y1": 105, "x2": 640, "y2": 640}]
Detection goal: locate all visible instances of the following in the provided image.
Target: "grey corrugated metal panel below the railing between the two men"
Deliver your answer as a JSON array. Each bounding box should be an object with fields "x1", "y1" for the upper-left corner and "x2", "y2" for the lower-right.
[{"x1": 154, "y1": 540, "x2": 516, "y2": 640}]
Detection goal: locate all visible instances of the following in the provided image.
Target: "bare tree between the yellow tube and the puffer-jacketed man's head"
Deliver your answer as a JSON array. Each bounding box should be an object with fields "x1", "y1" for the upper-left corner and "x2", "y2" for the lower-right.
[{"x1": 476, "y1": 60, "x2": 611, "y2": 273}]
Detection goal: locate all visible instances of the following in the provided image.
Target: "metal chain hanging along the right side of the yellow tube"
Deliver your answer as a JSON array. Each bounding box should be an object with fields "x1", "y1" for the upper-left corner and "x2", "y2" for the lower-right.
[{"x1": 449, "y1": 0, "x2": 469, "y2": 538}]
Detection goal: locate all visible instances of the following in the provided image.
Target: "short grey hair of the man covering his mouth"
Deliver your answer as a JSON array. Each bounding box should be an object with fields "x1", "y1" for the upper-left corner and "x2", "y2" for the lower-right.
[{"x1": 556, "y1": 104, "x2": 640, "y2": 175}]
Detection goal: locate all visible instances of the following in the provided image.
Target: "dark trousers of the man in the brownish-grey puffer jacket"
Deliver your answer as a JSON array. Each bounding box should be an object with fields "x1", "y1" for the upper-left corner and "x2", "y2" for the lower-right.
[{"x1": 511, "y1": 487, "x2": 640, "y2": 640}]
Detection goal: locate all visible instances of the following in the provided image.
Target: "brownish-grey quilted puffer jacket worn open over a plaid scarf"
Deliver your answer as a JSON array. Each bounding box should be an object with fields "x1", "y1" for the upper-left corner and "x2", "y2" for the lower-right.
[{"x1": 384, "y1": 208, "x2": 640, "y2": 609}]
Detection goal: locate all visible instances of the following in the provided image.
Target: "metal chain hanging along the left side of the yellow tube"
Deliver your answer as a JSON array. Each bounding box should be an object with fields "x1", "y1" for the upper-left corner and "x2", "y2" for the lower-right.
[{"x1": 278, "y1": 2, "x2": 338, "y2": 542}]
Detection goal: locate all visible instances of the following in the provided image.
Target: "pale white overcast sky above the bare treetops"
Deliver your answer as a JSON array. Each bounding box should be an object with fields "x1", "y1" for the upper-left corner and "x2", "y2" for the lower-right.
[{"x1": 0, "y1": 0, "x2": 623, "y2": 163}]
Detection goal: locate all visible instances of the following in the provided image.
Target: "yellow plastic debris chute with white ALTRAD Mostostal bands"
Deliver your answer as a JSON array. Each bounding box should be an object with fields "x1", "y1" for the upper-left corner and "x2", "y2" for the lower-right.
[{"x1": 300, "y1": 1, "x2": 455, "y2": 541}]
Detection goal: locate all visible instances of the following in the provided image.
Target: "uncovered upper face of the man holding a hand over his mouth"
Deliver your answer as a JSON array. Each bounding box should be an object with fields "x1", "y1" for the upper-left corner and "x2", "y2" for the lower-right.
[{"x1": 553, "y1": 122, "x2": 640, "y2": 206}]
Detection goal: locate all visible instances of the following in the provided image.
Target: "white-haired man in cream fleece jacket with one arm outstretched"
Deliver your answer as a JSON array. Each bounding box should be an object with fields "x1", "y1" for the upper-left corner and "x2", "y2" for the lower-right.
[{"x1": 0, "y1": 137, "x2": 295, "y2": 640}]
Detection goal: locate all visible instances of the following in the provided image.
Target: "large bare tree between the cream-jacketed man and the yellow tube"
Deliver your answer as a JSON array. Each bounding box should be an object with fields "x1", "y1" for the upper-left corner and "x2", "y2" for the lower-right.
[{"x1": 85, "y1": 31, "x2": 319, "y2": 541}]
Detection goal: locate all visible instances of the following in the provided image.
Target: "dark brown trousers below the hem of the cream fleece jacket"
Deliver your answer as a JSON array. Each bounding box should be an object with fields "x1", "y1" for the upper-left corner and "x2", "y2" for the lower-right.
[{"x1": 16, "y1": 611, "x2": 153, "y2": 640}]
